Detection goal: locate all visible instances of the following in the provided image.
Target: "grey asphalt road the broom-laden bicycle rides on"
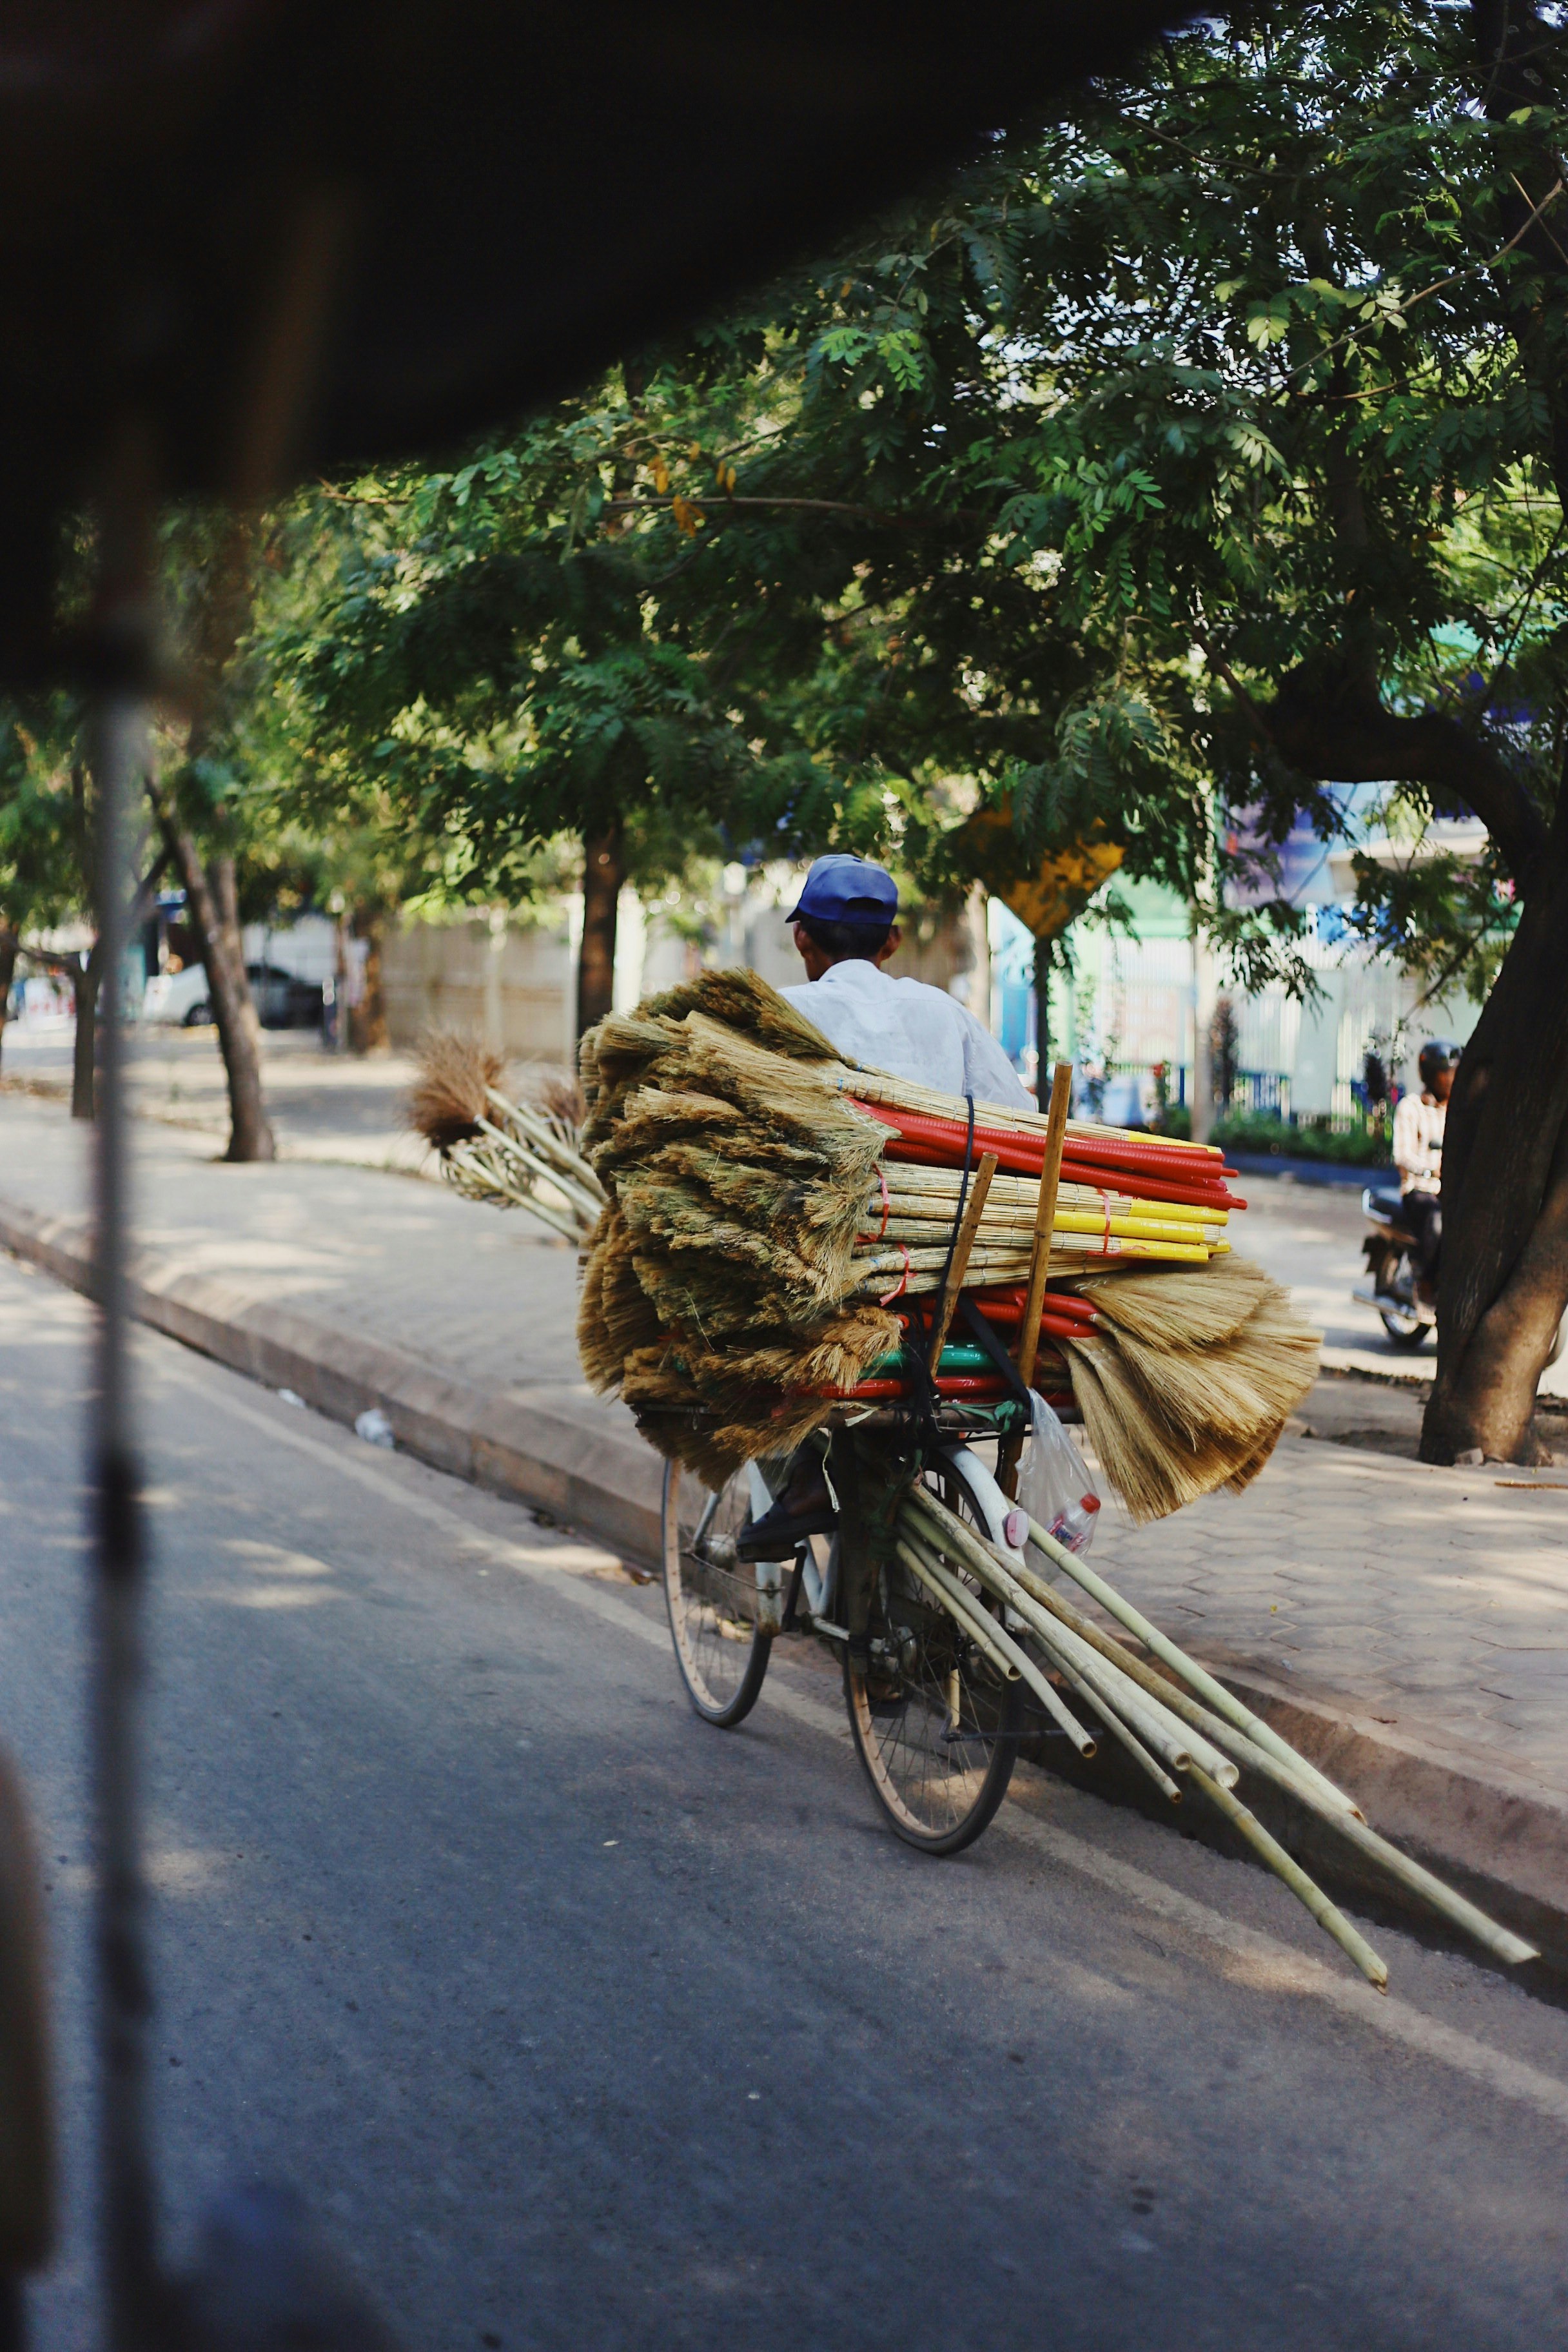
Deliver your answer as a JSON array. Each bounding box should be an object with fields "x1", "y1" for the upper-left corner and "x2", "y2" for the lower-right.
[{"x1": 0, "y1": 1260, "x2": 1568, "y2": 2352}]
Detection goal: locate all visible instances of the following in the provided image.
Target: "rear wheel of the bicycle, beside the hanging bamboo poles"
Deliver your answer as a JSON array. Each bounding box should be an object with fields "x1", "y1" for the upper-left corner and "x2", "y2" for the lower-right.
[{"x1": 844, "y1": 1463, "x2": 1025, "y2": 1854}]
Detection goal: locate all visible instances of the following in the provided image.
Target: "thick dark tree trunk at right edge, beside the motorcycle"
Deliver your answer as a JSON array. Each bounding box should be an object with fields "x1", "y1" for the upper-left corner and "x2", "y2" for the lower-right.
[{"x1": 1420, "y1": 856, "x2": 1568, "y2": 1463}]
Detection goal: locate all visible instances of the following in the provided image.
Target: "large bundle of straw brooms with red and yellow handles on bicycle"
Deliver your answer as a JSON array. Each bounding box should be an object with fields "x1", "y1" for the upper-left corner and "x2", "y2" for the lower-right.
[{"x1": 566, "y1": 972, "x2": 1319, "y2": 1520}]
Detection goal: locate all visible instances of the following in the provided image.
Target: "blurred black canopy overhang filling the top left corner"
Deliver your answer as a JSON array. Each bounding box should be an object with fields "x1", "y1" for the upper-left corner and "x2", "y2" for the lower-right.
[{"x1": 0, "y1": 0, "x2": 1182, "y2": 680}]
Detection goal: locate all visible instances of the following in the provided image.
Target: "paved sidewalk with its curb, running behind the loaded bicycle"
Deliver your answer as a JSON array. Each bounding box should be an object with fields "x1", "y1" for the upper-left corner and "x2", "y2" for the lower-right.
[{"x1": 0, "y1": 1093, "x2": 1568, "y2": 1952}]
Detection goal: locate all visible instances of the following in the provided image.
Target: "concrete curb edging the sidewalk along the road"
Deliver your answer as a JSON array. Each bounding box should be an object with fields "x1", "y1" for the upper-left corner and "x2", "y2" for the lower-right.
[{"x1": 0, "y1": 1202, "x2": 1568, "y2": 1975}]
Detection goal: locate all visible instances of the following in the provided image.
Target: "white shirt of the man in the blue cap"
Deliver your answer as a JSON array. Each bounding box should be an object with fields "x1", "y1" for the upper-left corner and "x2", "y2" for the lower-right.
[{"x1": 783, "y1": 957, "x2": 1034, "y2": 1110}]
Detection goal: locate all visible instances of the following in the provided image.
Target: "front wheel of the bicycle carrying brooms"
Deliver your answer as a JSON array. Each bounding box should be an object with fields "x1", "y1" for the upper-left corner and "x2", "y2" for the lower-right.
[{"x1": 663, "y1": 1463, "x2": 774, "y2": 1731}]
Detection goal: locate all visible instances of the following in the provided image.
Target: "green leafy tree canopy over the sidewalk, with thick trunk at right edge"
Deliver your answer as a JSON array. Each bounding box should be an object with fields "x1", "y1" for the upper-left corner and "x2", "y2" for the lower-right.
[{"x1": 273, "y1": 0, "x2": 1568, "y2": 1453}]
